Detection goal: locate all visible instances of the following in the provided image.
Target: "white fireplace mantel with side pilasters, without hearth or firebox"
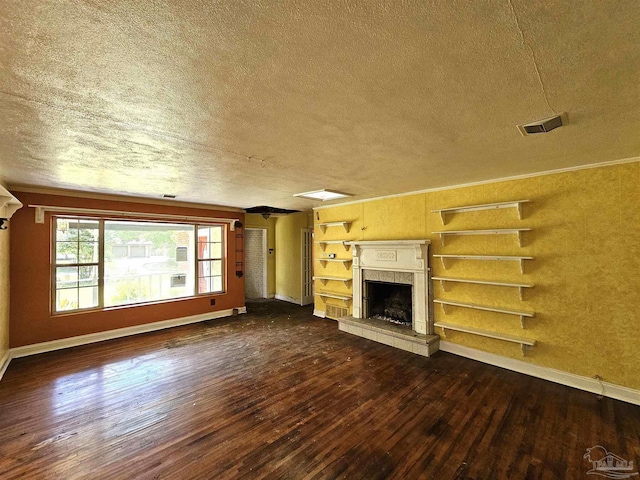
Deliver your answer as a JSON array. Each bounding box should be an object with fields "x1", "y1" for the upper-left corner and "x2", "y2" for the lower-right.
[{"x1": 347, "y1": 240, "x2": 433, "y2": 334}]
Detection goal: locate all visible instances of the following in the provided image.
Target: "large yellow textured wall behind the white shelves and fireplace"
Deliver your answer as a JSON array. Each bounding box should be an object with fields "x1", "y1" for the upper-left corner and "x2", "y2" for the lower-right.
[{"x1": 315, "y1": 162, "x2": 640, "y2": 389}]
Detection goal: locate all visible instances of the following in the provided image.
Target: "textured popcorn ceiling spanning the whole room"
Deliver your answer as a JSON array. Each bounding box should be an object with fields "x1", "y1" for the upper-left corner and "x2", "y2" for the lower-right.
[{"x1": 0, "y1": 0, "x2": 640, "y2": 209}]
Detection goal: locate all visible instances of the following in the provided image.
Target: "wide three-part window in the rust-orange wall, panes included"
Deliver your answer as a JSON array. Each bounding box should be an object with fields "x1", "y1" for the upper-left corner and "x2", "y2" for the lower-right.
[{"x1": 52, "y1": 217, "x2": 225, "y2": 313}]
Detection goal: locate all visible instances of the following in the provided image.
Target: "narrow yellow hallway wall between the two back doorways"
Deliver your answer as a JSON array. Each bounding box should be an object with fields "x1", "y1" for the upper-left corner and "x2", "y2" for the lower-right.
[{"x1": 276, "y1": 212, "x2": 313, "y2": 303}]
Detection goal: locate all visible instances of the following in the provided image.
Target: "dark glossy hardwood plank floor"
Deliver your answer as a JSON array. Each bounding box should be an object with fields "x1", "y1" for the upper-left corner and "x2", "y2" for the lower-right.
[{"x1": 0, "y1": 301, "x2": 640, "y2": 480}]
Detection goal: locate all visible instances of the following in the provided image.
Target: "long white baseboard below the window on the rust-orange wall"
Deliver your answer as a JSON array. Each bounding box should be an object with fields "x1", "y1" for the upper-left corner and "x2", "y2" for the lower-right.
[{"x1": 9, "y1": 307, "x2": 242, "y2": 358}]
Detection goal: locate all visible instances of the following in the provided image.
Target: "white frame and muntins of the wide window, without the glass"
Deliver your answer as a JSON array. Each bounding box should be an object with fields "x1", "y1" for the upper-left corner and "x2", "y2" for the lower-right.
[{"x1": 49, "y1": 214, "x2": 229, "y2": 316}]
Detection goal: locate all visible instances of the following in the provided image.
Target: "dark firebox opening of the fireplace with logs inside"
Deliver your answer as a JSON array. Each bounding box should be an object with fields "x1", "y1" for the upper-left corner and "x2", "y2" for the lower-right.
[{"x1": 365, "y1": 281, "x2": 413, "y2": 327}]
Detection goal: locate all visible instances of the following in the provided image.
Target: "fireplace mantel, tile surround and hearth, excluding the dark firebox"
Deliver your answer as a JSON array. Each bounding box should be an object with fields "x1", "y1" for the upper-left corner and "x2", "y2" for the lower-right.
[{"x1": 338, "y1": 240, "x2": 440, "y2": 357}]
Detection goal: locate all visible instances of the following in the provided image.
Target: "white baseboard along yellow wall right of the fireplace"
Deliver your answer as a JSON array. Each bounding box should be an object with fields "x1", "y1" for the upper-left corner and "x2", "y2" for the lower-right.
[{"x1": 440, "y1": 340, "x2": 640, "y2": 405}]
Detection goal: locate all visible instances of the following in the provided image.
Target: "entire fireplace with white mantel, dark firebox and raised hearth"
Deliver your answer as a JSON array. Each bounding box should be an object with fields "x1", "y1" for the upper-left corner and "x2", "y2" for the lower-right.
[{"x1": 338, "y1": 240, "x2": 440, "y2": 356}]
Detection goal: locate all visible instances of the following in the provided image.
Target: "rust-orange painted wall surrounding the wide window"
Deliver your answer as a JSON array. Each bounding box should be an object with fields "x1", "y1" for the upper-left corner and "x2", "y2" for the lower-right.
[{"x1": 9, "y1": 192, "x2": 244, "y2": 348}]
